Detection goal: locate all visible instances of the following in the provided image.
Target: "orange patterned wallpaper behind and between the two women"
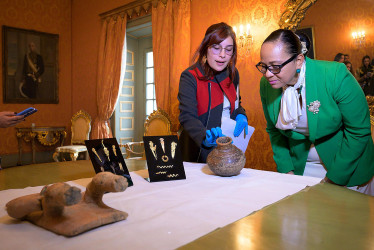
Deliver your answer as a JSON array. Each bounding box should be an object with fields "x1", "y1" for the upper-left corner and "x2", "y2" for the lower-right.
[{"x1": 191, "y1": 0, "x2": 287, "y2": 170}]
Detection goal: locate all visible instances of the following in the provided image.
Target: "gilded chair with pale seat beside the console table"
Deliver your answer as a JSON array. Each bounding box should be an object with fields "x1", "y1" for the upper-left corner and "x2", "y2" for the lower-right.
[{"x1": 53, "y1": 110, "x2": 91, "y2": 161}]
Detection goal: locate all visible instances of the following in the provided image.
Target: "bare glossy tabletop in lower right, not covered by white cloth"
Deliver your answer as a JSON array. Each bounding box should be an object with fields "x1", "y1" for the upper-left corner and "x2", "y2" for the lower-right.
[{"x1": 180, "y1": 183, "x2": 374, "y2": 250}]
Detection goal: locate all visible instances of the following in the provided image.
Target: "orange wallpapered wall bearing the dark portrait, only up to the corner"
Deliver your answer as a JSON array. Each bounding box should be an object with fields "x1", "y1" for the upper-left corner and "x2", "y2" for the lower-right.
[{"x1": 0, "y1": 0, "x2": 72, "y2": 155}]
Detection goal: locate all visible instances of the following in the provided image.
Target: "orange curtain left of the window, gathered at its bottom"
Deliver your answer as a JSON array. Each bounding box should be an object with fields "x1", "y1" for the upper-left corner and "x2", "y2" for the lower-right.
[{"x1": 91, "y1": 15, "x2": 127, "y2": 139}]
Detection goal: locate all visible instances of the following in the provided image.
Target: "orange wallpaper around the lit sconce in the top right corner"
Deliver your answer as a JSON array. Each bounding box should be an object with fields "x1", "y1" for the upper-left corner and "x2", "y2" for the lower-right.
[{"x1": 300, "y1": 0, "x2": 374, "y2": 73}]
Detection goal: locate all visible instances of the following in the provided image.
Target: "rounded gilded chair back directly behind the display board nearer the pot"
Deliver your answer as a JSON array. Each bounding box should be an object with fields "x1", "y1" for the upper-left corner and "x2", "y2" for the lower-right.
[{"x1": 144, "y1": 109, "x2": 172, "y2": 136}]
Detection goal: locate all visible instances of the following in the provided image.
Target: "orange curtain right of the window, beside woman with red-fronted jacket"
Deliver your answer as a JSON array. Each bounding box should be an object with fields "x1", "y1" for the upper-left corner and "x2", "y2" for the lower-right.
[{"x1": 152, "y1": 0, "x2": 191, "y2": 131}]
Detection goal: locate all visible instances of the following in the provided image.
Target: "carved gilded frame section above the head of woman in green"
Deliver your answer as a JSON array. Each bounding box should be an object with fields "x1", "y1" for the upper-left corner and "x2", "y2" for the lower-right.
[{"x1": 278, "y1": 0, "x2": 317, "y2": 30}]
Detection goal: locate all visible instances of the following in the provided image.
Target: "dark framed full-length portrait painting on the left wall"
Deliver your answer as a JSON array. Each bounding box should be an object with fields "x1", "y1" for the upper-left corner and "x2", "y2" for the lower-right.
[{"x1": 2, "y1": 26, "x2": 59, "y2": 103}]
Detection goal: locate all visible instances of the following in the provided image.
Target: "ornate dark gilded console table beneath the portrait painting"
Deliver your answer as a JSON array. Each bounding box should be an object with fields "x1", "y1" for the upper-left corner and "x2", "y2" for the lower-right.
[{"x1": 16, "y1": 127, "x2": 66, "y2": 165}]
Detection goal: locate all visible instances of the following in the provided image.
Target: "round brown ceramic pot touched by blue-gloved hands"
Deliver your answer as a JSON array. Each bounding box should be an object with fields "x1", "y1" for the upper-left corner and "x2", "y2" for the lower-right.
[{"x1": 206, "y1": 136, "x2": 245, "y2": 176}]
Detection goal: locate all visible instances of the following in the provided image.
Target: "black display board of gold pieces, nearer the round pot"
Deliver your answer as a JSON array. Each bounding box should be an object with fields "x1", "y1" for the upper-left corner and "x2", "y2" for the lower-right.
[{"x1": 143, "y1": 135, "x2": 186, "y2": 182}]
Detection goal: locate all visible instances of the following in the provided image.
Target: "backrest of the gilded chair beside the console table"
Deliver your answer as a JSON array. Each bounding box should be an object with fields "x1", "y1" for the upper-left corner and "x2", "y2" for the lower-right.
[{"x1": 71, "y1": 110, "x2": 91, "y2": 144}]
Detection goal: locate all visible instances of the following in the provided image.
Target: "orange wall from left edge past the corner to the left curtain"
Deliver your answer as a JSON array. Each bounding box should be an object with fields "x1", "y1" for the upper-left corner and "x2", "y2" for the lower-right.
[{"x1": 0, "y1": 0, "x2": 132, "y2": 156}]
